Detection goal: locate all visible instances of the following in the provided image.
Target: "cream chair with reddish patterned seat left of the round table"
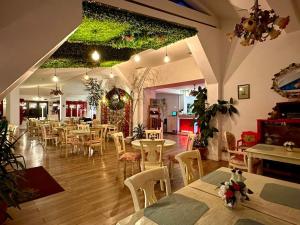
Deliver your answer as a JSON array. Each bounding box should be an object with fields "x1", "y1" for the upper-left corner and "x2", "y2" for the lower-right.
[{"x1": 112, "y1": 132, "x2": 141, "y2": 179}]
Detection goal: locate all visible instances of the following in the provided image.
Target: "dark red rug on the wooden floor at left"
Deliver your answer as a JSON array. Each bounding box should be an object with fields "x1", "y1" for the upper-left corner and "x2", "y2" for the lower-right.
[{"x1": 14, "y1": 166, "x2": 64, "y2": 203}]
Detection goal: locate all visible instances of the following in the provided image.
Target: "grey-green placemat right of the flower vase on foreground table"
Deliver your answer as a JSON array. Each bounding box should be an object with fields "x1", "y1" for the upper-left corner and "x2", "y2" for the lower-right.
[{"x1": 260, "y1": 183, "x2": 300, "y2": 209}]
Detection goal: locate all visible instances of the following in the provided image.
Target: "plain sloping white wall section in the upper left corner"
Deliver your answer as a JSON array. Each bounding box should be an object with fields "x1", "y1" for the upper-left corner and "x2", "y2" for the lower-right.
[{"x1": 0, "y1": 0, "x2": 82, "y2": 99}]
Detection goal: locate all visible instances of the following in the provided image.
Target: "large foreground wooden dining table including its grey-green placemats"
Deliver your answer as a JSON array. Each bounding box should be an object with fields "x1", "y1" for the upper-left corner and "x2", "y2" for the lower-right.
[{"x1": 117, "y1": 167, "x2": 300, "y2": 225}]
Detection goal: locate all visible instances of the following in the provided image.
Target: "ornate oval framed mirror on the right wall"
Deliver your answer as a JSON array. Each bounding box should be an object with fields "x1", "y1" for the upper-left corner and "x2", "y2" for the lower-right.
[{"x1": 271, "y1": 63, "x2": 300, "y2": 99}]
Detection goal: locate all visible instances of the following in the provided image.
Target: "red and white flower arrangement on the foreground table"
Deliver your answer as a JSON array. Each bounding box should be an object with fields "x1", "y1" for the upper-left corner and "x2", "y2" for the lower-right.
[{"x1": 218, "y1": 169, "x2": 253, "y2": 208}]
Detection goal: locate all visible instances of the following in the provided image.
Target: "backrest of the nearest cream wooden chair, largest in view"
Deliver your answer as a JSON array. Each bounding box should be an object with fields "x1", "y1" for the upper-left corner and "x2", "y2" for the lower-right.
[{"x1": 124, "y1": 166, "x2": 171, "y2": 212}]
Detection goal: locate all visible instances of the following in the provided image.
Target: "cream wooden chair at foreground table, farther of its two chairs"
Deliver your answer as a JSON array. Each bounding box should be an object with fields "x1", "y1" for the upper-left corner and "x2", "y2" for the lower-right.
[{"x1": 175, "y1": 150, "x2": 203, "y2": 186}]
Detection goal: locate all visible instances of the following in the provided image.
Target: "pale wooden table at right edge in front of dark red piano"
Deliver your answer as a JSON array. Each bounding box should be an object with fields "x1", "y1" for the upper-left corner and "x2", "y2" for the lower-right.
[{"x1": 246, "y1": 144, "x2": 300, "y2": 173}]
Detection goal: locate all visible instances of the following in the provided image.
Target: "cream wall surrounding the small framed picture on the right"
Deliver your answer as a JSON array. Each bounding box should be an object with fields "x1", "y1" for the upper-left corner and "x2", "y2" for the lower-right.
[{"x1": 224, "y1": 31, "x2": 300, "y2": 137}]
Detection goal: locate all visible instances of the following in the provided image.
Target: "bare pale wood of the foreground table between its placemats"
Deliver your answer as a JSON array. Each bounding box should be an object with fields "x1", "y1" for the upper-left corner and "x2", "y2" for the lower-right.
[{"x1": 117, "y1": 168, "x2": 300, "y2": 225}]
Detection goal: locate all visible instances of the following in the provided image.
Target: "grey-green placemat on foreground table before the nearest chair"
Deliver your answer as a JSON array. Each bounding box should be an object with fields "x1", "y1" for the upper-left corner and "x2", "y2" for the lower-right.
[{"x1": 144, "y1": 194, "x2": 209, "y2": 225}]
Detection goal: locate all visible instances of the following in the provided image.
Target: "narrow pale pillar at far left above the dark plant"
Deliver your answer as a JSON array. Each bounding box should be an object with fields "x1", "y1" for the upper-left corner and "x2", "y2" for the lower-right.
[{"x1": 5, "y1": 87, "x2": 20, "y2": 126}]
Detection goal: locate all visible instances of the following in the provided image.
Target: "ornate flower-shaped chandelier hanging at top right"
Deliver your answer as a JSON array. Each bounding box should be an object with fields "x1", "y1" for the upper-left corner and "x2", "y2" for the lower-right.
[{"x1": 227, "y1": 0, "x2": 290, "y2": 46}]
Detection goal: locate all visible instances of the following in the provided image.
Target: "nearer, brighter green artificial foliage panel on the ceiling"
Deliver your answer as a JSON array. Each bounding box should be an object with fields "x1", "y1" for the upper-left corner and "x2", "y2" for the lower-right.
[{"x1": 69, "y1": 1, "x2": 197, "y2": 50}]
